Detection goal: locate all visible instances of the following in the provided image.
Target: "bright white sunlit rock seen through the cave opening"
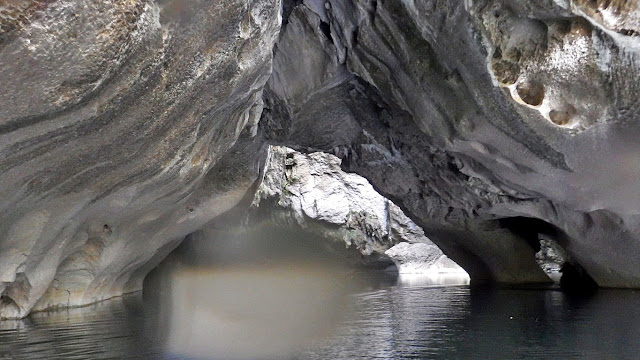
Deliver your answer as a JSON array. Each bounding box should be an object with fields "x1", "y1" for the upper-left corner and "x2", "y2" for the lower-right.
[{"x1": 252, "y1": 146, "x2": 466, "y2": 274}]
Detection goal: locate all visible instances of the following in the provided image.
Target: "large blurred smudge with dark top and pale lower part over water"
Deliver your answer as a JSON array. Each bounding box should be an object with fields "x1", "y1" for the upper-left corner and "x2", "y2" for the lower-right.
[{"x1": 147, "y1": 224, "x2": 469, "y2": 359}]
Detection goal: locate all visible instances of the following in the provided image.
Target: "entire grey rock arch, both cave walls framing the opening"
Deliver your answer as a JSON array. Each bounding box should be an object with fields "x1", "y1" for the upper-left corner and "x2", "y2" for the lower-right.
[{"x1": 0, "y1": 0, "x2": 640, "y2": 317}]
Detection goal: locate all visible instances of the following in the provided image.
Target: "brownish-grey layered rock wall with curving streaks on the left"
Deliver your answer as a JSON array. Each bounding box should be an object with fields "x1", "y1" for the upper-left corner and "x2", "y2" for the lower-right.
[{"x1": 0, "y1": 0, "x2": 280, "y2": 318}]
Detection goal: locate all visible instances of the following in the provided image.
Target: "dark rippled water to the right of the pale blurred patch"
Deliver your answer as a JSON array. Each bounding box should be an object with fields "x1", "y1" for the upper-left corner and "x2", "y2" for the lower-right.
[{"x1": 298, "y1": 286, "x2": 640, "y2": 359}]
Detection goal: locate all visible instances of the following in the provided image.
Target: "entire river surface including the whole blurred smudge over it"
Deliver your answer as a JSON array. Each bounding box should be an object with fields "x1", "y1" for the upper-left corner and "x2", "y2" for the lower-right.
[{"x1": 0, "y1": 222, "x2": 640, "y2": 360}]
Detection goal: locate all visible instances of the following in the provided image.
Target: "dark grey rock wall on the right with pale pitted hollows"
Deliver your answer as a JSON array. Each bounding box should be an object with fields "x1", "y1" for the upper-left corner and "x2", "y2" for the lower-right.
[{"x1": 262, "y1": 1, "x2": 640, "y2": 287}]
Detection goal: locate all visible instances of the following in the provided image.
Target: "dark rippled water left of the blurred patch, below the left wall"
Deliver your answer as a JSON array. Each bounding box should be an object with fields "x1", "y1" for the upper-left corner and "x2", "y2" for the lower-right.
[{"x1": 0, "y1": 294, "x2": 169, "y2": 360}]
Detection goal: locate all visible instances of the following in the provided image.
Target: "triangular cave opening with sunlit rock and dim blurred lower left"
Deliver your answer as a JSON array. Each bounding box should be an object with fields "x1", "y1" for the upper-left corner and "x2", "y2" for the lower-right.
[{"x1": 146, "y1": 146, "x2": 469, "y2": 292}]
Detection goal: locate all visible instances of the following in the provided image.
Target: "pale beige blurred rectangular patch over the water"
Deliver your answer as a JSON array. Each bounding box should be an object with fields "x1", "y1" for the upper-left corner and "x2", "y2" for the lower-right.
[{"x1": 162, "y1": 263, "x2": 355, "y2": 359}]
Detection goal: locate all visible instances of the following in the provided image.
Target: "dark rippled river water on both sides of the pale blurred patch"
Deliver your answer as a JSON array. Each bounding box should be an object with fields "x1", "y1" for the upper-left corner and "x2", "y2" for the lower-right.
[{"x1": 0, "y1": 272, "x2": 640, "y2": 360}]
